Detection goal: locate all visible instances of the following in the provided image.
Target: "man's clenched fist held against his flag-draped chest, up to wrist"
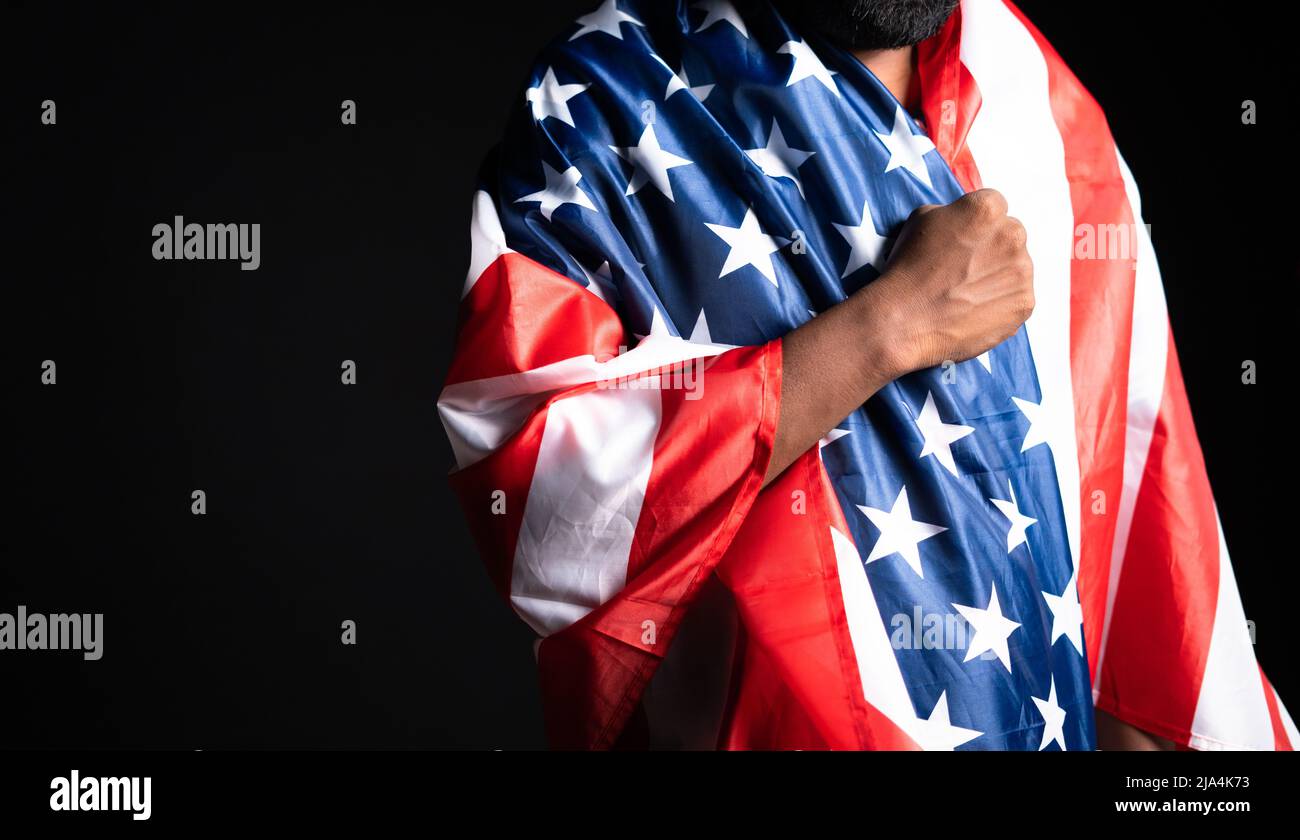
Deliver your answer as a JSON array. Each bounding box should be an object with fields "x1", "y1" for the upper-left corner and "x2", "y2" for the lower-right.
[{"x1": 872, "y1": 190, "x2": 1034, "y2": 373}]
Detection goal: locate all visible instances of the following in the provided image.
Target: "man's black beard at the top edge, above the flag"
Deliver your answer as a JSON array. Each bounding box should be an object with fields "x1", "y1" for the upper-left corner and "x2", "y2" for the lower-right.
[{"x1": 772, "y1": 0, "x2": 958, "y2": 49}]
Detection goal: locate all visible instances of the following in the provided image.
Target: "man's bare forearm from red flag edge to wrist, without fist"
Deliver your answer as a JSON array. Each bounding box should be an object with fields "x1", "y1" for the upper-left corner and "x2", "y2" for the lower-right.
[{"x1": 763, "y1": 283, "x2": 905, "y2": 486}]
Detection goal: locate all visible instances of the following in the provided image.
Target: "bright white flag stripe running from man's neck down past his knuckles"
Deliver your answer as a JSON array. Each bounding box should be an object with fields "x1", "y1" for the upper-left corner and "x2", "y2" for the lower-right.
[{"x1": 961, "y1": 0, "x2": 1080, "y2": 567}]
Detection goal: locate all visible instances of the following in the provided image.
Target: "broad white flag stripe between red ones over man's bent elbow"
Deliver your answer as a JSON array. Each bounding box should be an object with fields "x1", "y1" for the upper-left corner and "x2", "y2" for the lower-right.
[{"x1": 510, "y1": 377, "x2": 662, "y2": 636}]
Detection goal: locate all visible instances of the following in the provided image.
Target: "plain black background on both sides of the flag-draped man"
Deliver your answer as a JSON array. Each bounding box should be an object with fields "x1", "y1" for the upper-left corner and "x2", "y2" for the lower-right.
[{"x1": 0, "y1": 0, "x2": 1300, "y2": 749}]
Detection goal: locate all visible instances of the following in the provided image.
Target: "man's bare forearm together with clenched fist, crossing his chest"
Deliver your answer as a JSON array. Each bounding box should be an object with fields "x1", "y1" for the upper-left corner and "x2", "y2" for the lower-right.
[{"x1": 763, "y1": 190, "x2": 1034, "y2": 485}]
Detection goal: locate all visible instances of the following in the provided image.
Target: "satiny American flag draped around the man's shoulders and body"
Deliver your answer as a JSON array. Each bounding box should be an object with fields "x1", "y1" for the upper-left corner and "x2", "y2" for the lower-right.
[{"x1": 439, "y1": 0, "x2": 1300, "y2": 750}]
